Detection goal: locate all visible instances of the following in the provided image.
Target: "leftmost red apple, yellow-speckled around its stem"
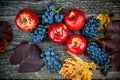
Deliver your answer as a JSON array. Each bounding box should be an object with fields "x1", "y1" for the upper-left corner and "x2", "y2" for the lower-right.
[{"x1": 15, "y1": 8, "x2": 39, "y2": 32}]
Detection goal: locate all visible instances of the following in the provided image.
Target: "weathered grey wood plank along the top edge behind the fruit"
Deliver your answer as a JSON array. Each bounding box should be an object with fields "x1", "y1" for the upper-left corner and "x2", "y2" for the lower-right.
[{"x1": 0, "y1": 0, "x2": 120, "y2": 16}]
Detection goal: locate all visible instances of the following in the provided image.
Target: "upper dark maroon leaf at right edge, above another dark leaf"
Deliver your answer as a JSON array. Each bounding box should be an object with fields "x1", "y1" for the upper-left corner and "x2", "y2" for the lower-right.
[{"x1": 100, "y1": 20, "x2": 120, "y2": 53}]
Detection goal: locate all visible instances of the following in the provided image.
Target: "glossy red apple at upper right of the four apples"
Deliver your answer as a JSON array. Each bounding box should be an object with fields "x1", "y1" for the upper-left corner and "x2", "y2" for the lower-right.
[{"x1": 64, "y1": 9, "x2": 86, "y2": 30}]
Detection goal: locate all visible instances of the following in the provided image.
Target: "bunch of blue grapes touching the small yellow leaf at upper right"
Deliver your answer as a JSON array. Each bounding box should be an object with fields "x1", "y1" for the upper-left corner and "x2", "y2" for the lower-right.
[{"x1": 82, "y1": 16, "x2": 100, "y2": 38}]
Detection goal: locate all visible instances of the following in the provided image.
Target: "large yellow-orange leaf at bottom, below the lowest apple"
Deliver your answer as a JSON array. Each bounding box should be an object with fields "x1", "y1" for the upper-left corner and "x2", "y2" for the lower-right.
[{"x1": 59, "y1": 53, "x2": 96, "y2": 80}]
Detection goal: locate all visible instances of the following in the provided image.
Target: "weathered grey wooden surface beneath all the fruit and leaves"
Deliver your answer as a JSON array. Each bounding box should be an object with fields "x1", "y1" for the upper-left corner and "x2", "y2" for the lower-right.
[{"x1": 0, "y1": 0, "x2": 120, "y2": 79}]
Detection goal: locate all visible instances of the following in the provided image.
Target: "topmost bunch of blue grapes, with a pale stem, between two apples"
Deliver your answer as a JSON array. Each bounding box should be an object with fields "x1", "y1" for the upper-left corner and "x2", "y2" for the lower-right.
[{"x1": 41, "y1": 4, "x2": 64, "y2": 24}]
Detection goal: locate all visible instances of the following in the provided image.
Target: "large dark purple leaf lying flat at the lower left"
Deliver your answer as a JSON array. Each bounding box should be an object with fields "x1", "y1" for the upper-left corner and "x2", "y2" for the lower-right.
[{"x1": 9, "y1": 41, "x2": 44, "y2": 72}]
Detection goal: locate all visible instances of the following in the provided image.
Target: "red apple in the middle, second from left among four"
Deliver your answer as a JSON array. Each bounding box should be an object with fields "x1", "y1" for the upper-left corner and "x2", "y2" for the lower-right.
[{"x1": 48, "y1": 23, "x2": 69, "y2": 44}]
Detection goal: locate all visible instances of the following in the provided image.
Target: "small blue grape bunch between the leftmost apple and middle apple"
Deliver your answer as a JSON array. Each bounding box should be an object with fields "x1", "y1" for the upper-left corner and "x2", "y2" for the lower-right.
[{"x1": 30, "y1": 24, "x2": 47, "y2": 43}]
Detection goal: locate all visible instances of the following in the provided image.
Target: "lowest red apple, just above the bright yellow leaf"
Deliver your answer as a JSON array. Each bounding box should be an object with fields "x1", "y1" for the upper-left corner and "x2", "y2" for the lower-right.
[{"x1": 66, "y1": 34, "x2": 87, "y2": 54}]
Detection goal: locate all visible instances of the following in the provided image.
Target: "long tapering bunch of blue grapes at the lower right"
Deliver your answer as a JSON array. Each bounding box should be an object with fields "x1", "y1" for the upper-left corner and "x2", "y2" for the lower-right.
[{"x1": 86, "y1": 42, "x2": 112, "y2": 76}]
